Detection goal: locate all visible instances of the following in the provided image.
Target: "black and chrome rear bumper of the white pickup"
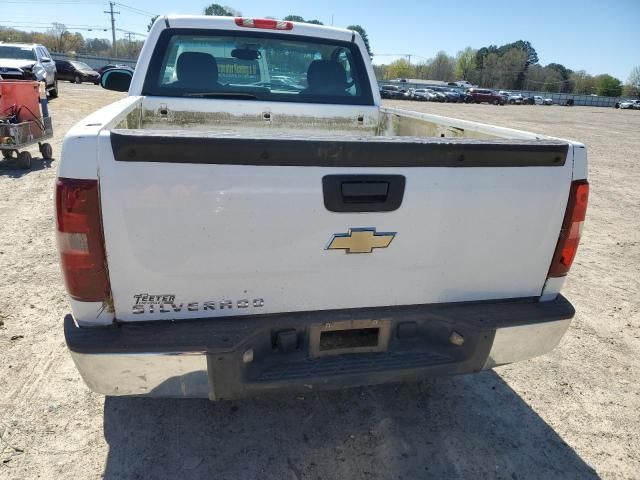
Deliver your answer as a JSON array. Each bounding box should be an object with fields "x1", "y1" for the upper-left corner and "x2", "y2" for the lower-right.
[{"x1": 64, "y1": 296, "x2": 574, "y2": 400}]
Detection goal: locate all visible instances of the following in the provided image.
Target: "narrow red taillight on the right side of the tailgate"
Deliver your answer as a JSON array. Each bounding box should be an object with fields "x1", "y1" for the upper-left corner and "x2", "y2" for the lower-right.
[{"x1": 548, "y1": 180, "x2": 589, "y2": 277}]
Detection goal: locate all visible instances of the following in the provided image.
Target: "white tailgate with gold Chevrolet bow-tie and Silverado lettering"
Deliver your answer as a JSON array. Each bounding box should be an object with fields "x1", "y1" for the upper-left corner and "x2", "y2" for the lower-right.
[{"x1": 99, "y1": 130, "x2": 573, "y2": 321}]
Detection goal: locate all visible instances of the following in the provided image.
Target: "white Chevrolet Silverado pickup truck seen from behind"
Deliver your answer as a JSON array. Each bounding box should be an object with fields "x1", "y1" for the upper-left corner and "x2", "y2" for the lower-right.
[{"x1": 56, "y1": 16, "x2": 588, "y2": 399}]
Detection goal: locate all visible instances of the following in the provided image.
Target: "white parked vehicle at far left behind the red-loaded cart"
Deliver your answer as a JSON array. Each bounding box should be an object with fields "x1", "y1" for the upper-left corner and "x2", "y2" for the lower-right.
[{"x1": 0, "y1": 42, "x2": 58, "y2": 98}]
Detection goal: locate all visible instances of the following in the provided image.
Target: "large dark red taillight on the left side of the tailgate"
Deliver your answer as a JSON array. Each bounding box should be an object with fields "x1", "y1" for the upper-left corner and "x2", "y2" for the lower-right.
[{"x1": 56, "y1": 178, "x2": 110, "y2": 302}]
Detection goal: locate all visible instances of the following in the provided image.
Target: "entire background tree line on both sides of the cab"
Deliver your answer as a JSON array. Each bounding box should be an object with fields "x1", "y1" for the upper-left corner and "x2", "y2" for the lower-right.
[{"x1": 0, "y1": 3, "x2": 640, "y2": 98}]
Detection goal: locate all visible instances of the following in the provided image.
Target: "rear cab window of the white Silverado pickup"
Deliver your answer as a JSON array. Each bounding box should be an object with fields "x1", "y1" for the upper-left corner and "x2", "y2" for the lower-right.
[{"x1": 142, "y1": 29, "x2": 374, "y2": 105}]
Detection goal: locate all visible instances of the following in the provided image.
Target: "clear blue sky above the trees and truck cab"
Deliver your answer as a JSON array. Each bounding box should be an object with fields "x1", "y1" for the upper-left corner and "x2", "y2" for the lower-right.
[{"x1": 0, "y1": 0, "x2": 640, "y2": 81}]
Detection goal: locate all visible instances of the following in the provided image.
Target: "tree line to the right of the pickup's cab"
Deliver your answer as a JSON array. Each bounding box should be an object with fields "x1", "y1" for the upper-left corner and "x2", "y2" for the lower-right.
[{"x1": 374, "y1": 40, "x2": 640, "y2": 98}]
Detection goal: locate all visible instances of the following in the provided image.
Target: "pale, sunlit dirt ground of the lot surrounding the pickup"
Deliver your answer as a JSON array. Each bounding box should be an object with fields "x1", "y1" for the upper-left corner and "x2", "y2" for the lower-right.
[{"x1": 0, "y1": 83, "x2": 640, "y2": 480}]
